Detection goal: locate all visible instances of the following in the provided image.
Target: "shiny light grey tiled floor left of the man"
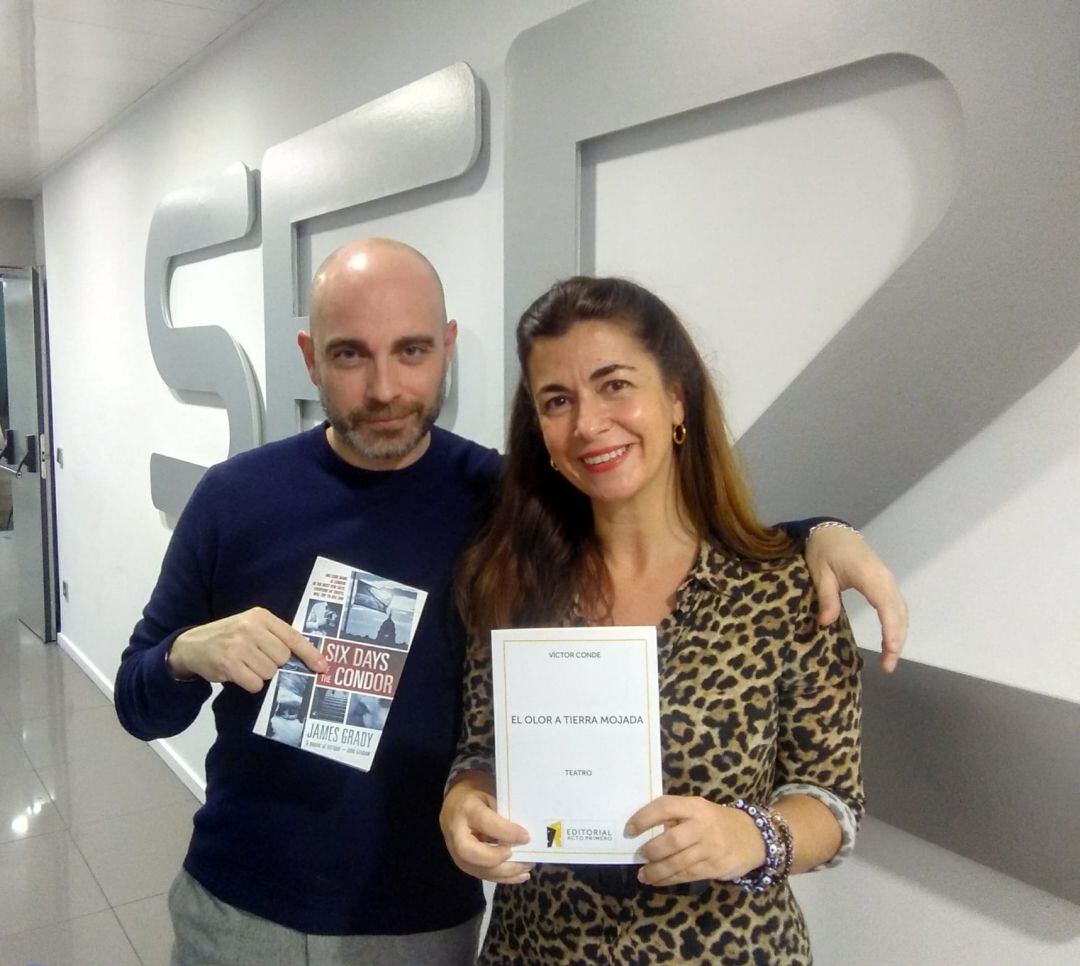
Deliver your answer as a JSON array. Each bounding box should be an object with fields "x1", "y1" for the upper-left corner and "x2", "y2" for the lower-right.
[{"x1": 0, "y1": 532, "x2": 198, "y2": 966}]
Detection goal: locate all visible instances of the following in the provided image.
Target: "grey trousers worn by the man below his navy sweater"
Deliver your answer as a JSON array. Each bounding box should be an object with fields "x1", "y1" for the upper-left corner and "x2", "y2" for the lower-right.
[{"x1": 168, "y1": 869, "x2": 482, "y2": 966}]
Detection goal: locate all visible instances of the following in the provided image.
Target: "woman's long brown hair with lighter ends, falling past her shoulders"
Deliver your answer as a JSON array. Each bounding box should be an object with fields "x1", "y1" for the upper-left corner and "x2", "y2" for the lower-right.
[{"x1": 457, "y1": 276, "x2": 794, "y2": 633}]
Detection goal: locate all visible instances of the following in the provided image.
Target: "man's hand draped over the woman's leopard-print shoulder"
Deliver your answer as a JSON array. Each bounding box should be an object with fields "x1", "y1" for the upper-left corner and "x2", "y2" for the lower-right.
[{"x1": 805, "y1": 526, "x2": 907, "y2": 671}]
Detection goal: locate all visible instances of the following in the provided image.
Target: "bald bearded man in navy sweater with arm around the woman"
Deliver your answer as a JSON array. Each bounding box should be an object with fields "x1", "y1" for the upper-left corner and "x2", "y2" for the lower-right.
[{"x1": 116, "y1": 239, "x2": 903, "y2": 966}]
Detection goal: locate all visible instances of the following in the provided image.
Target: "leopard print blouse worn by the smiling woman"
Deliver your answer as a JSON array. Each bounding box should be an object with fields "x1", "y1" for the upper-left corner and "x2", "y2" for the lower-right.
[{"x1": 455, "y1": 546, "x2": 864, "y2": 966}]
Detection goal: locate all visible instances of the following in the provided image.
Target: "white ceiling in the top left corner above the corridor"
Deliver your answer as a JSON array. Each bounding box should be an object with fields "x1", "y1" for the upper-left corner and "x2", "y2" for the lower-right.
[{"x1": 0, "y1": 0, "x2": 283, "y2": 199}]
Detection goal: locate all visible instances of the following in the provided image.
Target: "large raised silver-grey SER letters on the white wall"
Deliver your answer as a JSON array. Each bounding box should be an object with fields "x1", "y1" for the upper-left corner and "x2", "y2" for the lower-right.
[{"x1": 146, "y1": 0, "x2": 1080, "y2": 535}]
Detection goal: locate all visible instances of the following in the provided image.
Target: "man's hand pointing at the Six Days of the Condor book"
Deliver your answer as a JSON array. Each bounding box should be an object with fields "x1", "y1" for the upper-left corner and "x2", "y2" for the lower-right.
[{"x1": 168, "y1": 607, "x2": 327, "y2": 694}]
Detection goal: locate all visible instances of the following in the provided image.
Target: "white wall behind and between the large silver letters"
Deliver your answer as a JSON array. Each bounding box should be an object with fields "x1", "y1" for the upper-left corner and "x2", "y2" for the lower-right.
[{"x1": 38, "y1": 0, "x2": 1080, "y2": 964}]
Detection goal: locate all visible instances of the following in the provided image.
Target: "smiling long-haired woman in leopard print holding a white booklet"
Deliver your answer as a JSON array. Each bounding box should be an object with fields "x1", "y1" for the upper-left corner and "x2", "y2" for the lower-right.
[{"x1": 441, "y1": 278, "x2": 863, "y2": 964}]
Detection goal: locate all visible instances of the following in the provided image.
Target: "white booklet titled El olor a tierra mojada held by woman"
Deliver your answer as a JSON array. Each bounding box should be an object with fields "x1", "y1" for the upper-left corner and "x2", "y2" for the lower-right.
[{"x1": 491, "y1": 627, "x2": 663, "y2": 864}]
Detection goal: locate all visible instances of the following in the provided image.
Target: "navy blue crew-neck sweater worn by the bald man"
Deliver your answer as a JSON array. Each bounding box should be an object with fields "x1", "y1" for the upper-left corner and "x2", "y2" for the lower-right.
[{"x1": 116, "y1": 428, "x2": 499, "y2": 935}]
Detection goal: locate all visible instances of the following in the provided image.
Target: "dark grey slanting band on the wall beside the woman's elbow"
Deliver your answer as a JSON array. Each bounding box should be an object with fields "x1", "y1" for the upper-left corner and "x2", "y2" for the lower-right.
[{"x1": 861, "y1": 652, "x2": 1080, "y2": 916}]
